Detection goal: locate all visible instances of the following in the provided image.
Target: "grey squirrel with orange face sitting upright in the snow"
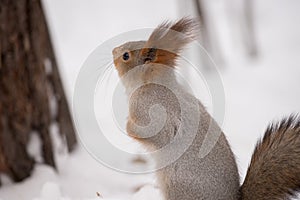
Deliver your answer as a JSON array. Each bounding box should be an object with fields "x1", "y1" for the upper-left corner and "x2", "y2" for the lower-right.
[{"x1": 112, "y1": 17, "x2": 300, "y2": 200}]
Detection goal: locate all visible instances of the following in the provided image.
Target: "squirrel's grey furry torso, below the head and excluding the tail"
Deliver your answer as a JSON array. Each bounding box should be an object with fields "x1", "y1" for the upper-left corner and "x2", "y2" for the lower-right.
[{"x1": 123, "y1": 66, "x2": 239, "y2": 200}]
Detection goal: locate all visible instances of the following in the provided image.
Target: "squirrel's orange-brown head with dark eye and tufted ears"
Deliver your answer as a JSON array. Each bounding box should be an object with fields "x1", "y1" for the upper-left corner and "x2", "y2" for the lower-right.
[{"x1": 112, "y1": 18, "x2": 199, "y2": 86}]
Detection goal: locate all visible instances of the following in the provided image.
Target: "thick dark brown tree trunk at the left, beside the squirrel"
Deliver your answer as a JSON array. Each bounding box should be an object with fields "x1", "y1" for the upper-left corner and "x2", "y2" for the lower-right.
[{"x1": 0, "y1": 0, "x2": 76, "y2": 181}]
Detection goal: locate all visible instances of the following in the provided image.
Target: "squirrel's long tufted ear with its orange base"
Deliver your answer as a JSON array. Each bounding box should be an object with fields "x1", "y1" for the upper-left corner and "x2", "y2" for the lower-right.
[{"x1": 141, "y1": 17, "x2": 199, "y2": 65}]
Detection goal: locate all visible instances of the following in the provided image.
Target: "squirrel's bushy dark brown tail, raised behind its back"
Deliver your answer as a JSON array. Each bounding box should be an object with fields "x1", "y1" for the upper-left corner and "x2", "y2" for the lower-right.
[{"x1": 240, "y1": 116, "x2": 300, "y2": 200}]
